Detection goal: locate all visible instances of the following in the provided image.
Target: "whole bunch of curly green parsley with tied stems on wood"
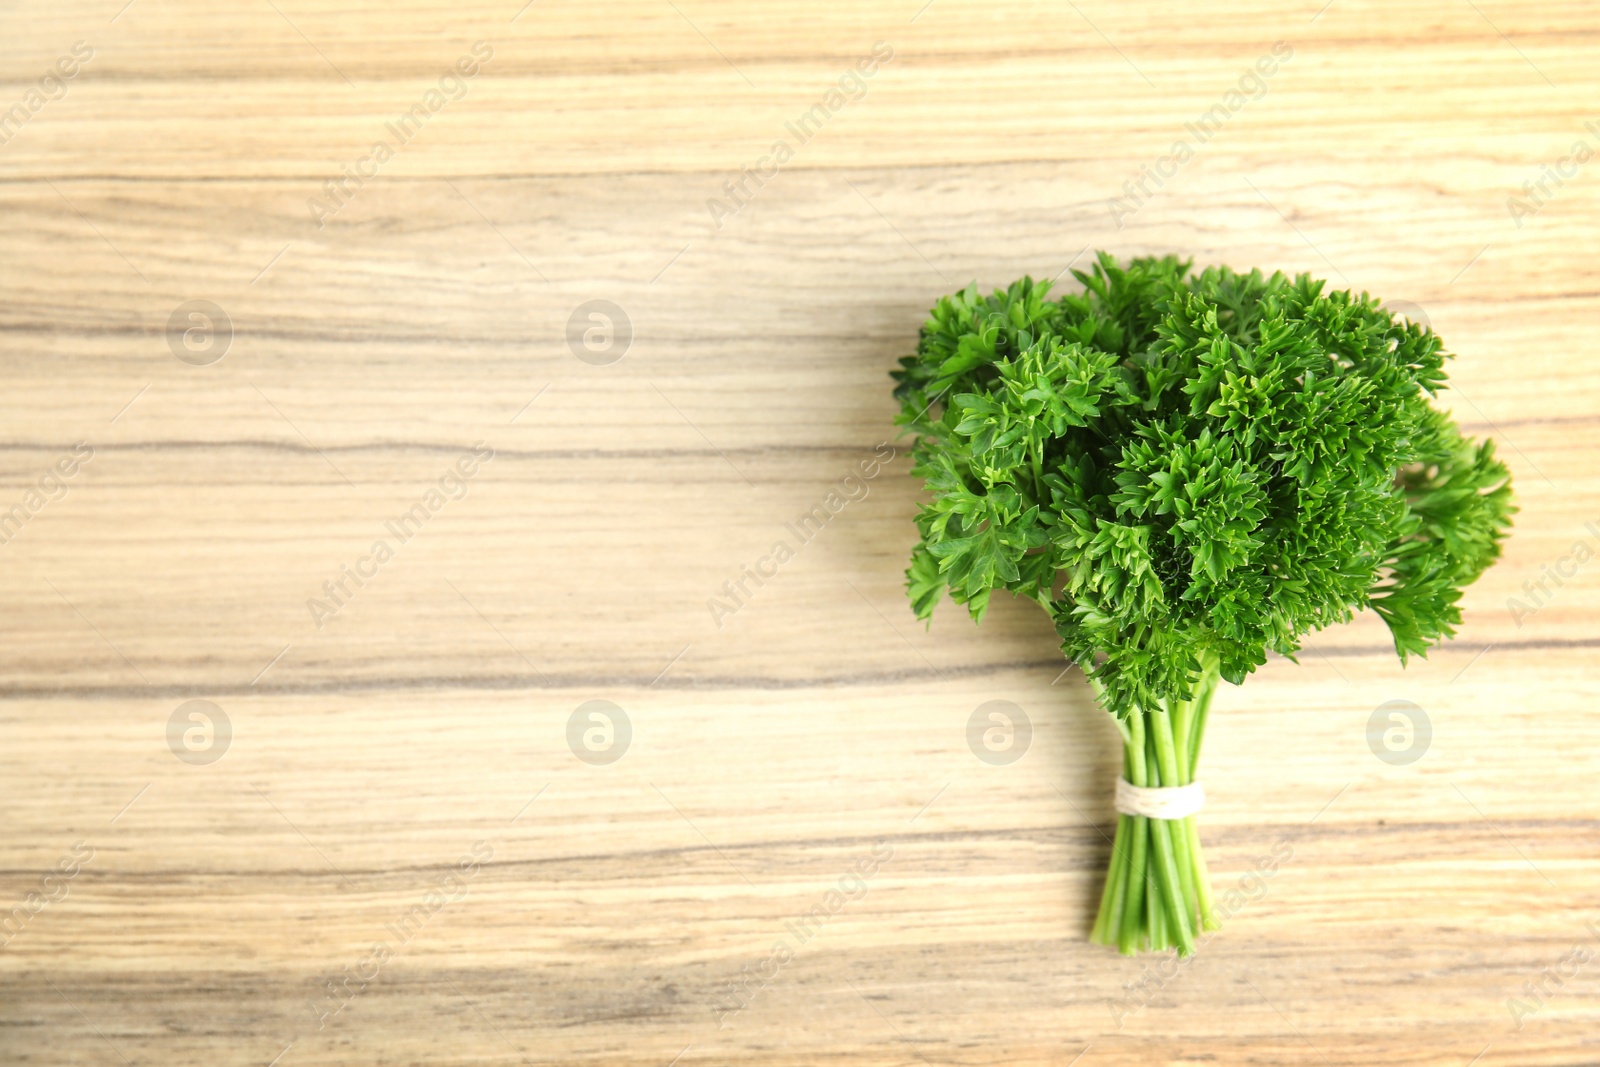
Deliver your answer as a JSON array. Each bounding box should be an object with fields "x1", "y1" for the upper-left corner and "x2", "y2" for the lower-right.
[{"x1": 893, "y1": 253, "x2": 1515, "y2": 953}]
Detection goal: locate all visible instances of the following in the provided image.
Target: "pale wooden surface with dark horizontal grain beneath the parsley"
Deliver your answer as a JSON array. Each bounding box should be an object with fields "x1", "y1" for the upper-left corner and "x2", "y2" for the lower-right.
[{"x1": 0, "y1": 0, "x2": 1600, "y2": 1067}]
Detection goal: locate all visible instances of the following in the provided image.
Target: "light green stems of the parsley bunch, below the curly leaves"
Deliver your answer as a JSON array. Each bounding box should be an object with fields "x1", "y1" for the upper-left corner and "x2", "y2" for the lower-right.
[{"x1": 1090, "y1": 667, "x2": 1218, "y2": 955}]
